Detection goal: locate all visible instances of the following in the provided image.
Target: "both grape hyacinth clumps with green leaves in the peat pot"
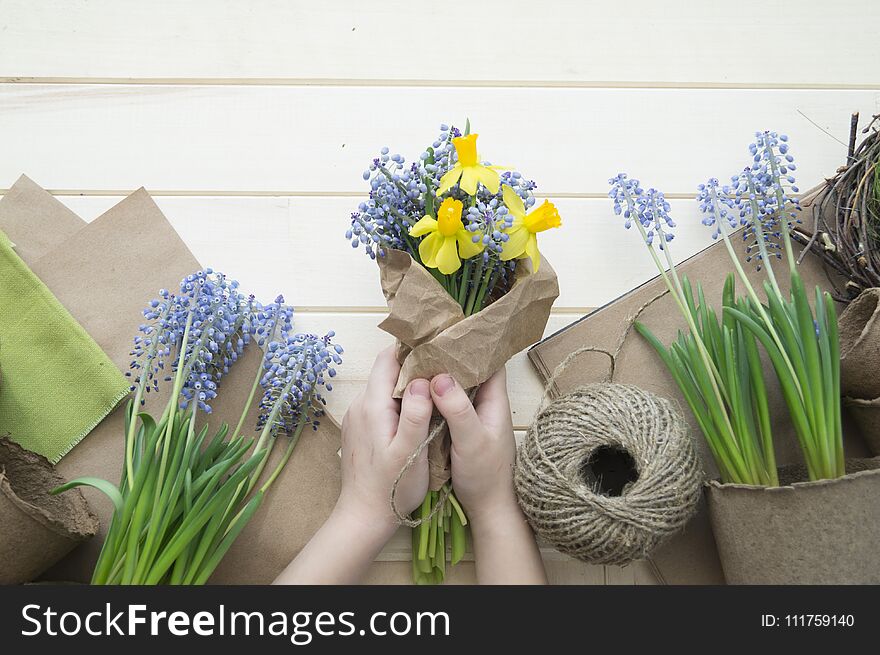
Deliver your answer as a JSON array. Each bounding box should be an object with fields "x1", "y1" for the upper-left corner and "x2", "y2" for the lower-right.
[{"x1": 609, "y1": 132, "x2": 844, "y2": 486}]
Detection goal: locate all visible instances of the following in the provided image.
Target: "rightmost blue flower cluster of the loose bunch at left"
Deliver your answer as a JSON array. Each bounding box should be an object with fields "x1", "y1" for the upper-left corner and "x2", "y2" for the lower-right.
[{"x1": 257, "y1": 331, "x2": 343, "y2": 434}]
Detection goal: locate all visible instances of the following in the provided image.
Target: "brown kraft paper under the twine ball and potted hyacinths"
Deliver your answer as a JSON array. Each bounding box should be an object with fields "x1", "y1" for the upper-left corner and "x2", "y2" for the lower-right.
[{"x1": 529, "y1": 231, "x2": 866, "y2": 584}]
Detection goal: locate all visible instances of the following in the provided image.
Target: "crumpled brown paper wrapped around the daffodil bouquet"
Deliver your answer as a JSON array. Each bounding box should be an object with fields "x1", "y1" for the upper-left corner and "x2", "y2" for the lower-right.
[{"x1": 377, "y1": 250, "x2": 559, "y2": 490}]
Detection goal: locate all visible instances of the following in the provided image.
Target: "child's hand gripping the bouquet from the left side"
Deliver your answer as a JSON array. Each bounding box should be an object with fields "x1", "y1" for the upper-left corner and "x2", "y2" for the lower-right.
[{"x1": 337, "y1": 348, "x2": 433, "y2": 534}]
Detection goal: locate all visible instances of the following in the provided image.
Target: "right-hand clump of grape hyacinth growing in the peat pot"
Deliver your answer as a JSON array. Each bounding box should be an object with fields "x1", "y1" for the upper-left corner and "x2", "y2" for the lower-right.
[{"x1": 697, "y1": 131, "x2": 844, "y2": 480}]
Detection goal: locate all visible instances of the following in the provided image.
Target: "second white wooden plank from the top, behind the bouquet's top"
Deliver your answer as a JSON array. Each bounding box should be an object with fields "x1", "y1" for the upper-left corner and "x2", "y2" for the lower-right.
[{"x1": 0, "y1": 84, "x2": 868, "y2": 197}]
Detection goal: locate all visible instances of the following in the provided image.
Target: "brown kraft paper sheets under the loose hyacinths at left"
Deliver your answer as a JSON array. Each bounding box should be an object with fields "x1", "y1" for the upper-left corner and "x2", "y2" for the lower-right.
[{"x1": 0, "y1": 177, "x2": 340, "y2": 584}]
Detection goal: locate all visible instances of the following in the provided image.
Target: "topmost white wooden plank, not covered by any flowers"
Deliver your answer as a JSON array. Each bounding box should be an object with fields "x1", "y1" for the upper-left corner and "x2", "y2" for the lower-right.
[{"x1": 0, "y1": 0, "x2": 880, "y2": 87}]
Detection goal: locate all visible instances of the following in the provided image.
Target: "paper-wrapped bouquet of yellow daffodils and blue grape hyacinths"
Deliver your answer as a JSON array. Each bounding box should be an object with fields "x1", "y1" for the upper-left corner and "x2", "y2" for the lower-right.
[{"x1": 346, "y1": 122, "x2": 561, "y2": 584}]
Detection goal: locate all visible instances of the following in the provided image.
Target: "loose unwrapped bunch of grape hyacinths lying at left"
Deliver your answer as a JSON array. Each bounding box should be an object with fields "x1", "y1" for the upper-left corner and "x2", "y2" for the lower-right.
[{"x1": 55, "y1": 269, "x2": 342, "y2": 584}]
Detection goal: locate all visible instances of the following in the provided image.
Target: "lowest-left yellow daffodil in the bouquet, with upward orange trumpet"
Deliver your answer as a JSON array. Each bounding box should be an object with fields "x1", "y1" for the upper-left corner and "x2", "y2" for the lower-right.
[{"x1": 409, "y1": 198, "x2": 485, "y2": 275}]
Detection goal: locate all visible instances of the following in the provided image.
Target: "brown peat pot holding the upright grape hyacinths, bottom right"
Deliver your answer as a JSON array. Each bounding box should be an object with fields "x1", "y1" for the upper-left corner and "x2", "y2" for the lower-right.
[{"x1": 706, "y1": 458, "x2": 880, "y2": 584}]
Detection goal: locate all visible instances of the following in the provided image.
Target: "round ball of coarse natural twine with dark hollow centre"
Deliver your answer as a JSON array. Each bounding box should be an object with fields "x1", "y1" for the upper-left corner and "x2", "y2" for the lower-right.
[{"x1": 514, "y1": 383, "x2": 702, "y2": 564}]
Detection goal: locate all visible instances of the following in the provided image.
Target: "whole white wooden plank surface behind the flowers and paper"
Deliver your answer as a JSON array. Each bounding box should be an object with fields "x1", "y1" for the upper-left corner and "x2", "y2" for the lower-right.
[{"x1": 0, "y1": 0, "x2": 880, "y2": 584}]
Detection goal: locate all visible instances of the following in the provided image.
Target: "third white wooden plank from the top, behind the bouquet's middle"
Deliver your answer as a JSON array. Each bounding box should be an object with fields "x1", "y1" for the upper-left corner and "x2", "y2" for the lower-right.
[{"x1": 51, "y1": 196, "x2": 711, "y2": 313}]
